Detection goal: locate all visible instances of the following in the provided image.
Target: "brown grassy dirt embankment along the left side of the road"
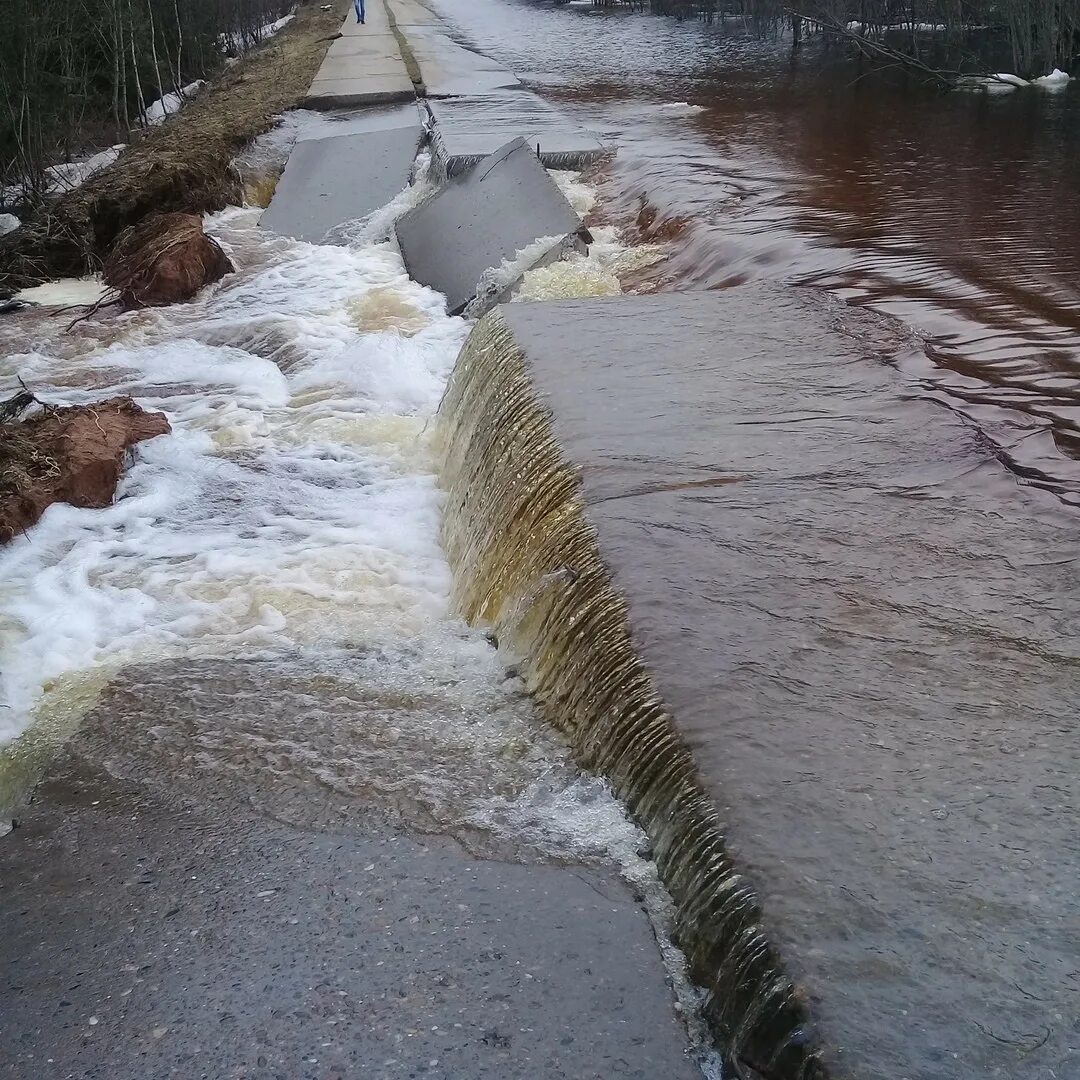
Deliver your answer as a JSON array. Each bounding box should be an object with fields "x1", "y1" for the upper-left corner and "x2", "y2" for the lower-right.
[{"x1": 0, "y1": 0, "x2": 350, "y2": 288}]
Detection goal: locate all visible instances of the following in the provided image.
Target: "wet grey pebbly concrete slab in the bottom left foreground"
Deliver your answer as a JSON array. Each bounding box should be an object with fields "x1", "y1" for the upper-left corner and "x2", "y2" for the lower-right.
[{"x1": 0, "y1": 661, "x2": 700, "y2": 1080}]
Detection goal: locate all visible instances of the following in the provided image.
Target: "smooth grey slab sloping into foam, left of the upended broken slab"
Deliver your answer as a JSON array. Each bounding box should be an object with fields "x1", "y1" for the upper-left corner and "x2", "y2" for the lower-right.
[{"x1": 259, "y1": 124, "x2": 422, "y2": 243}]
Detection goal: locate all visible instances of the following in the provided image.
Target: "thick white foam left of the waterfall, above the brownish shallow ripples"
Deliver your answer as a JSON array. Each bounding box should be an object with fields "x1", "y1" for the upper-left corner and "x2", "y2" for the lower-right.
[{"x1": 0, "y1": 187, "x2": 468, "y2": 742}]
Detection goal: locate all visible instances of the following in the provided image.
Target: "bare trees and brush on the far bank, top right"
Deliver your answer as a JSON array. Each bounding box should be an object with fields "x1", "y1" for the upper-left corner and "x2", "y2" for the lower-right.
[{"x1": 651, "y1": 0, "x2": 1080, "y2": 76}]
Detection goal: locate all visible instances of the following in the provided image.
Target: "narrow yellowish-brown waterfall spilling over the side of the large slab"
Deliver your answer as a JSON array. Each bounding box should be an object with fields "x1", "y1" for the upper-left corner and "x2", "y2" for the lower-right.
[{"x1": 438, "y1": 310, "x2": 824, "y2": 1080}]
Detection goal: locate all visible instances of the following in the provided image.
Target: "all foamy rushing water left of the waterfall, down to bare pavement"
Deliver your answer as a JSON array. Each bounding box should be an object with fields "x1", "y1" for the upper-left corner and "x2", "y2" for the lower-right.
[{"x1": 0, "y1": 145, "x2": 725, "y2": 1080}]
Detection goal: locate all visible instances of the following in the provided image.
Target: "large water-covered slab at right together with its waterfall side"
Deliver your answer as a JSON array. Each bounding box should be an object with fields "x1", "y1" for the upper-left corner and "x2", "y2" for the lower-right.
[{"x1": 440, "y1": 284, "x2": 1077, "y2": 1080}]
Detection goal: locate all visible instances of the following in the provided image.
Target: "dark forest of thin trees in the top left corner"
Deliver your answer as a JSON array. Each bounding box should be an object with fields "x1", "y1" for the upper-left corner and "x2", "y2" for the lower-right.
[{"x1": 0, "y1": 0, "x2": 295, "y2": 204}]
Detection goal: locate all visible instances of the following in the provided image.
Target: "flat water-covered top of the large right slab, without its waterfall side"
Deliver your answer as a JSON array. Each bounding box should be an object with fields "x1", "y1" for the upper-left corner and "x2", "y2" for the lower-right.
[{"x1": 483, "y1": 285, "x2": 1080, "y2": 1080}]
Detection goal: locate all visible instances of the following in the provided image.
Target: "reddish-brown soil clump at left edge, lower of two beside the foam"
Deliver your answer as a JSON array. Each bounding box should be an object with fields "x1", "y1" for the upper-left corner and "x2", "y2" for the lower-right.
[{"x1": 0, "y1": 395, "x2": 172, "y2": 544}]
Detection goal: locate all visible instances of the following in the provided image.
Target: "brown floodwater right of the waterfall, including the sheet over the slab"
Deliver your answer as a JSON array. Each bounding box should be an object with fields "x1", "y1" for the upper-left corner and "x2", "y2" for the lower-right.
[{"x1": 423, "y1": 0, "x2": 1080, "y2": 1080}]
